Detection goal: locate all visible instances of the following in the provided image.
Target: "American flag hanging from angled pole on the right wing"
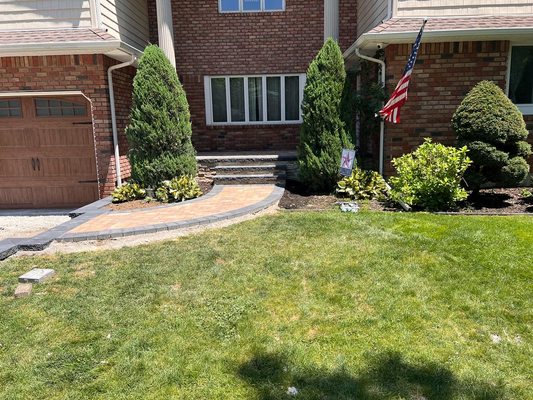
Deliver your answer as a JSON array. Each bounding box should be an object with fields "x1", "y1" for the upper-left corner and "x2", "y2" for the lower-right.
[{"x1": 379, "y1": 20, "x2": 427, "y2": 124}]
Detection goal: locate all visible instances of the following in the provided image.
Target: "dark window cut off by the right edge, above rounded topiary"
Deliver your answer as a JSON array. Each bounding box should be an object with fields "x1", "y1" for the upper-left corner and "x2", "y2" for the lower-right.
[{"x1": 509, "y1": 46, "x2": 533, "y2": 114}]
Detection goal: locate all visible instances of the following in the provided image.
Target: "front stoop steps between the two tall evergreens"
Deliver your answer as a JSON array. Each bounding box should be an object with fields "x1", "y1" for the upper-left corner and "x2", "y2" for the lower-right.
[{"x1": 197, "y1": 151, "x2": 297, "y2": 186}]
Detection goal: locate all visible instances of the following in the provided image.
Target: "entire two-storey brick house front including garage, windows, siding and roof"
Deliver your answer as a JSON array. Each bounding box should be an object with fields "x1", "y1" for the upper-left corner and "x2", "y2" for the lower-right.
[{"x1": 0, "y1": 0, "x2": 533, "y2": 208}]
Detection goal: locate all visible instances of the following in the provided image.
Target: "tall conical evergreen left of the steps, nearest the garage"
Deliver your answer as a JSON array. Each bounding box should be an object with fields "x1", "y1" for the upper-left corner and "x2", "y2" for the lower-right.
[{"x1": 126, "y1": 45, "x2": 197, "y2": 187}]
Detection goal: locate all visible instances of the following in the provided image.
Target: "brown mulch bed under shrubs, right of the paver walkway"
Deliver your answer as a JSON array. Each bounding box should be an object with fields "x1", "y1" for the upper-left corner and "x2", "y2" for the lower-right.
[{"x1": 279, "y1": 181, "x2": 533, "y2": 214}]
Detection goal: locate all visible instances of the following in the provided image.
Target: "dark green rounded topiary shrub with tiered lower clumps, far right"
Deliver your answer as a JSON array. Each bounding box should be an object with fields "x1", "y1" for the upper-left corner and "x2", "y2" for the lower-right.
[{"x1": 452, "y1": 81, "x2": 531, "y2": 191}]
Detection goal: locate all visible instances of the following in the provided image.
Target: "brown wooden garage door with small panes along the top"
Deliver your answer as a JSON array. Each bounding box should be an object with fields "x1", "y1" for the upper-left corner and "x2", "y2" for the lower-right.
[{"x1": 0, "y1": 97, "x2": 98, "y2": 208}]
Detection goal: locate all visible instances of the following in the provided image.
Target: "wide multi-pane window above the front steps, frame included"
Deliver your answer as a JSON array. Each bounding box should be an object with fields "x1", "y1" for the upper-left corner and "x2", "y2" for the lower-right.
[{"x1": 204, "y1": 74, "x2": 305, "y2": 125}]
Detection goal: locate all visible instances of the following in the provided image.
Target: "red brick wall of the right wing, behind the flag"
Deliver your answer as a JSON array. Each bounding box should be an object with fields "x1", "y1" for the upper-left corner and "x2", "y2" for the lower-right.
[{"x1": 385, "y1": 41, "x2": 533, "y2": 175}]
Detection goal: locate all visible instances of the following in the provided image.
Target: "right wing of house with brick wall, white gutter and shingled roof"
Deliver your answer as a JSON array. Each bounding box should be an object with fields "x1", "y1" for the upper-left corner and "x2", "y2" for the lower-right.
[{"x1": 345, "y1": 0, "x2": 533, "y2": 175}]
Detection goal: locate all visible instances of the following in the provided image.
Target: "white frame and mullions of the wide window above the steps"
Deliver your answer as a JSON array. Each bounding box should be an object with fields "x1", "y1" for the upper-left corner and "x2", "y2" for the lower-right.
[{"x1": 204, "y1": 74, "x2": 306, "y2": 126}]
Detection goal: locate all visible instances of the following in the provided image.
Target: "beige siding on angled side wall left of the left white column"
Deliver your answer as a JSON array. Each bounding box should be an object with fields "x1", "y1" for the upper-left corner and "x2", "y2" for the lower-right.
[{"x1": 100, "y1": 0, "x2": 149, "y2": 51}]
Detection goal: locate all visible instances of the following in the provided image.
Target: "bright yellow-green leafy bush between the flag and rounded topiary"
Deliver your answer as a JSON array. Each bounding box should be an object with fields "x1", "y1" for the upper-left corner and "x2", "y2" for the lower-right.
[{"x1": 390, "y1": 139, "x2": 471, "y2": 211}]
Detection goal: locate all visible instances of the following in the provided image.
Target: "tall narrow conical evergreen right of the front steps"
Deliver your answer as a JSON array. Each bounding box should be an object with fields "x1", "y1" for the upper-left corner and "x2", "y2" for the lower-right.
[{"x1": 298, "y1": 38, "x2": 351, "y2": 192}]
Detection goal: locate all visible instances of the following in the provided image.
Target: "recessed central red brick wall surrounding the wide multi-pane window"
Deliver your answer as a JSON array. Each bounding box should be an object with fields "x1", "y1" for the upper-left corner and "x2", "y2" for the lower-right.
[{"x1": 148, "y1": 0, "x2": 324, "y2": 151}]
